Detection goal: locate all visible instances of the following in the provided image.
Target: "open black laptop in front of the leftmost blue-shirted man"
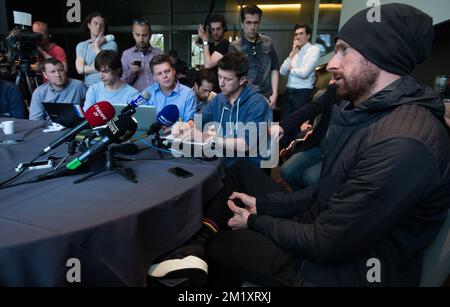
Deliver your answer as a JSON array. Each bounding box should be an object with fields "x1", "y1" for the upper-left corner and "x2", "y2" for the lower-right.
[{"x1": 42, "y1": 102, "x2": 84, "y2": 128}]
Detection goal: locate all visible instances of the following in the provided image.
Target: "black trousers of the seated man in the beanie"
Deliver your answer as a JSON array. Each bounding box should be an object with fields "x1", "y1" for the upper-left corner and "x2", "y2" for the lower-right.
[{"x1": 205, "y1": 161, "x2": 302, "y2": 287}]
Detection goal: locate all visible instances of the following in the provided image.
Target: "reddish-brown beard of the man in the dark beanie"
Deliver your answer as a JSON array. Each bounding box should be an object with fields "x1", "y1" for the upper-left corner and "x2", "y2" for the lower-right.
[{"x1": 337, "y1": 59, "x2": 380, "y2": 102}]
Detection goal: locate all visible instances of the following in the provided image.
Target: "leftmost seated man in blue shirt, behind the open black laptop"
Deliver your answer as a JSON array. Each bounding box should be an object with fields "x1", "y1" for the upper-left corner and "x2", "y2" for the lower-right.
[{"x1": 29, "y1": 58, "x2": 86, "y2": 120}]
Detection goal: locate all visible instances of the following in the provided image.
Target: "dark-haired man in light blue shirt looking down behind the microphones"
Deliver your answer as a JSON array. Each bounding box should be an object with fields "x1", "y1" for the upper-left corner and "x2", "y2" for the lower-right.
[{"x1": 84, "y1": 50, "x2": 139, "y2": 111}]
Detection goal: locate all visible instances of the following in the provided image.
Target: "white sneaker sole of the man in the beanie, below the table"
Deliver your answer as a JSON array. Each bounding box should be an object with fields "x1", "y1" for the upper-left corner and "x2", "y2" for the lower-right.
[{"x1": 148, "y1": 256, "x2": 208, "y2": 278}]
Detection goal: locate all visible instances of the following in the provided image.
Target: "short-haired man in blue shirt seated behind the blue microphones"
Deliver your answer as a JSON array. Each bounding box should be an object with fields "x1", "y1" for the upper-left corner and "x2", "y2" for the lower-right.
[{"x1": 145, "y1": 54, "x2": 196, "y2": 127}]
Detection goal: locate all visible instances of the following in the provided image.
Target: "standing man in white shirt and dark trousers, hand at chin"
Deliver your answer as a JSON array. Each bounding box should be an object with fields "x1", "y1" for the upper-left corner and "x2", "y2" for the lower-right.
[{"x1": 280, "y1": 24, "x2": 320, "y2": 119}]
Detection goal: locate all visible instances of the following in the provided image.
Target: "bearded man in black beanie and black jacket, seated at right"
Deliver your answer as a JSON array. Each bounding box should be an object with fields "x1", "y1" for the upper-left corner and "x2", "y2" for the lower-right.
[{"x1": 148, "y1": 4, "x2": 450, "y2": 286}]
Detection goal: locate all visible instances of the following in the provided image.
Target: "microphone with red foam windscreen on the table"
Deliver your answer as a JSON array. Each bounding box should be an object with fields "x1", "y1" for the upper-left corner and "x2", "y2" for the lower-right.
[{"x1": 39, "y1": 101, "x2": 116, "y2": 157}]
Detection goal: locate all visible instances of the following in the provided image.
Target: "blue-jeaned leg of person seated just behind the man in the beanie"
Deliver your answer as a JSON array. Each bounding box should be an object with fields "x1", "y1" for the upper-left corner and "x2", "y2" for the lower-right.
[{"x1": 281, "y1": 146, "x2": 323, "y2": 191}]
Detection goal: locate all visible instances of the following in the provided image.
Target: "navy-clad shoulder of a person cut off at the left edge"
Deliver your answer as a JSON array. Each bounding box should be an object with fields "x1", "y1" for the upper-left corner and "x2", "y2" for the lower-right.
[{"x1": 0, "y1": 79, "x2": 25, "y2": 119}]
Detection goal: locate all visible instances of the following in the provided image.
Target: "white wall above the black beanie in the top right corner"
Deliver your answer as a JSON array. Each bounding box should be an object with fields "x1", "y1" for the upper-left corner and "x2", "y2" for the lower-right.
[{"x1": 340, "y1": 0, "x2": 450, "y2": 27}]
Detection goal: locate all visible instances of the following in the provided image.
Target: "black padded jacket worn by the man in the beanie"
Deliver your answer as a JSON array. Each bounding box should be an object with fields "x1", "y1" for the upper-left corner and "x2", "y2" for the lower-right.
[{"x1": 248, "y1": 76, "x2": 450, "y2": 286}]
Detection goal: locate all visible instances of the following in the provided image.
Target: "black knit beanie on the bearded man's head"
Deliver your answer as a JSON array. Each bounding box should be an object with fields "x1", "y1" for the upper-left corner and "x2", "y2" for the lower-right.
[{"x1": 336, "y1": 3, "x2": 434, "y2": 76}]
